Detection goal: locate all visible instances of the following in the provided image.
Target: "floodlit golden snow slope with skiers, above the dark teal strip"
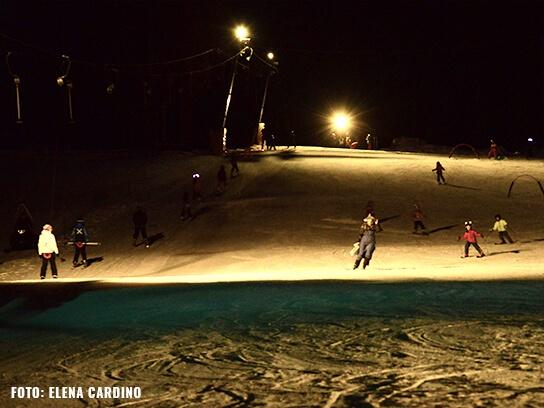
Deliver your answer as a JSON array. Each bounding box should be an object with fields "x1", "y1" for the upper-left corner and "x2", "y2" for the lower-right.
[{"x1": 0, "y1": 147, "x2": 544, "y2": 282}]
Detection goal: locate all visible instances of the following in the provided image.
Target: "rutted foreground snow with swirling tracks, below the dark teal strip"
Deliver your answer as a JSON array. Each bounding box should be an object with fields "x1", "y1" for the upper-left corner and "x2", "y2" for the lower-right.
[{"x1": 1, "y1": 318, "x2": 544, "y2": 407}]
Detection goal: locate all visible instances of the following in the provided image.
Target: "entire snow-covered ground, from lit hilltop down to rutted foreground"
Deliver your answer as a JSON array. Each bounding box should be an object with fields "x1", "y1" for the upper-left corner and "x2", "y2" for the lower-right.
[{"x1": 0, "y1": 148, "x2": 544, "y2": 407}]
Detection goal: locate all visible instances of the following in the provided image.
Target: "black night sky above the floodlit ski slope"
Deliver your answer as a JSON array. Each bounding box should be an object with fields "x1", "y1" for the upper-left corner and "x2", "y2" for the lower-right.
[{"x1": 0, "y1": 0, "x2": 544, "y2": 150}]
